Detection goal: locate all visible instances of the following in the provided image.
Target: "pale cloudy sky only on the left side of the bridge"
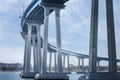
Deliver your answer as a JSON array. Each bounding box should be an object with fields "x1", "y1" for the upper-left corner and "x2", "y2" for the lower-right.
[{"x1": 0, "y1": 0, "x2": 30, "y2": 63}]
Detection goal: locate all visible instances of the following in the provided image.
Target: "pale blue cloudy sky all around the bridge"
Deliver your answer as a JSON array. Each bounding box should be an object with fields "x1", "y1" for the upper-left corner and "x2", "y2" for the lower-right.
[{"x1": 0, "y1": 0, "x2": 120, "y2": 63}]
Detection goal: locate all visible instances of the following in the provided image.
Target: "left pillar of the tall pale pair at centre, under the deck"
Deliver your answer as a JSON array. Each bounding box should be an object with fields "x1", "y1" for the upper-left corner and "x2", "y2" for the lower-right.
[{"x1": 42, "y1": 7, "x2": 50, "y2": 73}]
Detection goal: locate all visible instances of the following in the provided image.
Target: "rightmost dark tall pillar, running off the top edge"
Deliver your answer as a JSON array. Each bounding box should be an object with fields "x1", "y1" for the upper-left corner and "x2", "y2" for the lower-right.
[{"x1": 106, "y1": 0, "x2": 117, "y2": 72}]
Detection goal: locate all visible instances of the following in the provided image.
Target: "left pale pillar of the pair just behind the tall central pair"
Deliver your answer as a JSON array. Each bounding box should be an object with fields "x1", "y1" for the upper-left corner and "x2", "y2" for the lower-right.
[{"x1": 27, "y1": 23, "x2": 32, "y2": 73}]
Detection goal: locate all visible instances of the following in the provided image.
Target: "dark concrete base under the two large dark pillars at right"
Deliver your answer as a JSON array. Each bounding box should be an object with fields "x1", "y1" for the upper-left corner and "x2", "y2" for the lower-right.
[{"x1": 88, "y1": 72, "x2": 120, "y2": 80}]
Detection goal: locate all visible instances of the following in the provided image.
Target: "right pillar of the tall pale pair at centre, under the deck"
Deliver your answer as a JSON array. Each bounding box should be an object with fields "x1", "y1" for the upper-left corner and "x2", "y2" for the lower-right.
[{"x1": 55, "y1": 9, "x2": 63, "y2": 73}]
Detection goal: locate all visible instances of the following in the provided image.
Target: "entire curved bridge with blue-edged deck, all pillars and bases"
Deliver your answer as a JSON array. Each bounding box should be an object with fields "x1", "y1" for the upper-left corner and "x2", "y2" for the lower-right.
[{"x1": 21, "y1": 0, "x2": 120, "y2": 80}]
